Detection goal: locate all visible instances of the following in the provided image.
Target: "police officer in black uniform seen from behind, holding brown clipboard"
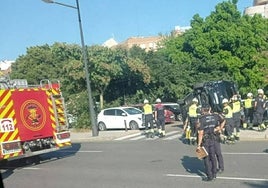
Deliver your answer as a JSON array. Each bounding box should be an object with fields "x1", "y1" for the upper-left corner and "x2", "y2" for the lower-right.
[{"x1": 197, "y1": 105, "x2": 225, "y2": 181}]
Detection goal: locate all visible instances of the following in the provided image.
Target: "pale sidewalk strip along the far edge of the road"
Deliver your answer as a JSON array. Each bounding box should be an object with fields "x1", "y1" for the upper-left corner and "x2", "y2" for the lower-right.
[{"x1": 71, "y1": 129, "x2": 268, "y2": 142}]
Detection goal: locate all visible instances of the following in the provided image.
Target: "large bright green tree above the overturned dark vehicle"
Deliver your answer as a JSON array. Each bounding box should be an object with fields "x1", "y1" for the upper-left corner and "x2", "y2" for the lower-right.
[{"x1": 160, "y1": 1, "x2": 268, "y2": 97}]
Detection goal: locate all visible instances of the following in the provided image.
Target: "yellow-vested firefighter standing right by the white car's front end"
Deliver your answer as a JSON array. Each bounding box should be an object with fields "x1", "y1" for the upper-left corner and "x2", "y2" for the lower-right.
[{"x1": 143, "y1": 99, "x2": 154, "y2": 136}]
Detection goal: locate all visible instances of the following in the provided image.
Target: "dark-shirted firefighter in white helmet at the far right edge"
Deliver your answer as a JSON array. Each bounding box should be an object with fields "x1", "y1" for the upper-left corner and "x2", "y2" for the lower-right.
[{"x1": 253, "y1": 89, "x2": 266, "y2": 131}]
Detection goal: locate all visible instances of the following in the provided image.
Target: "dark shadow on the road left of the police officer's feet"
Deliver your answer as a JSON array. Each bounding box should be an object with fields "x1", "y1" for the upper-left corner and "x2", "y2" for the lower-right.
[{"x1": 181, "y1": 156, "x2": 205, "y2": 177}]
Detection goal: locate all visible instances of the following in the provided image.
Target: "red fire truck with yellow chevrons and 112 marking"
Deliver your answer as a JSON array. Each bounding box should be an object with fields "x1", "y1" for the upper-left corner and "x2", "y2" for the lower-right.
[{"x1": 0, "y1": 79, "x2": 71, "y2": 162}]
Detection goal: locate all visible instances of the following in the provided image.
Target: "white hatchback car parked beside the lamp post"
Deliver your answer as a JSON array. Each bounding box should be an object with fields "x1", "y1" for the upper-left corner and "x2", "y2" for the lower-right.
[{"x1": 97, "y1": 107, "x2": 144, "y2": 131}]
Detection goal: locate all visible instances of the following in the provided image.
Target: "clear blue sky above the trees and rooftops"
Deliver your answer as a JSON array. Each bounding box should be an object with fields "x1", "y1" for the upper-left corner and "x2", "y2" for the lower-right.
[{"x1": 0, "y1": 0, "x2": 253, "y2": 61}]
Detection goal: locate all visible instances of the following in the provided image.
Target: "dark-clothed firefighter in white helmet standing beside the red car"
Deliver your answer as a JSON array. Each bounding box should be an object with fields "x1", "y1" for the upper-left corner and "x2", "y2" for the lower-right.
[{"x1": 154, "y1": 98, "x2": 166, "y2": 137}]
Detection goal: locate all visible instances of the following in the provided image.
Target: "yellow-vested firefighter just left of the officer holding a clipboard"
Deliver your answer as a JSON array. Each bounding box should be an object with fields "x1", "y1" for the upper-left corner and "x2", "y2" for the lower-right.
[{"x1": 184, "y1": 98, "x2": 200, "y2": 144}]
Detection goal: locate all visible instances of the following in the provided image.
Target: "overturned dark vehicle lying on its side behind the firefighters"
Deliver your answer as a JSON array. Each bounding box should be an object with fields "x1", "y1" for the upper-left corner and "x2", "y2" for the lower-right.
[{"x1": 179, "y1": 80, "x2": 238, "y2": 120}]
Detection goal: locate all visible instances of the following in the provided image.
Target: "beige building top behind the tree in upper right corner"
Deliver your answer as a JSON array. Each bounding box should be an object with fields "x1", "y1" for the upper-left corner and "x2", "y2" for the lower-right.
[{"x1": 244, "y1": 0, "x2": 268, "y2": 18}]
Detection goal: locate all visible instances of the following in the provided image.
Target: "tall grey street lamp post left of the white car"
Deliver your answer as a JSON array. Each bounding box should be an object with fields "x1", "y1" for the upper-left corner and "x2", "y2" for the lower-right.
[{"x1": 42, "y1": 0, "x2": 98, "y2": 136}]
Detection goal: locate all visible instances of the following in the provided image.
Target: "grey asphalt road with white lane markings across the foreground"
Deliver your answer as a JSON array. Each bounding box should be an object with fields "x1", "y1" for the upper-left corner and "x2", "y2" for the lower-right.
[{"x1": 1, "y1": 139, "x2": 268, "y2": 188}]
